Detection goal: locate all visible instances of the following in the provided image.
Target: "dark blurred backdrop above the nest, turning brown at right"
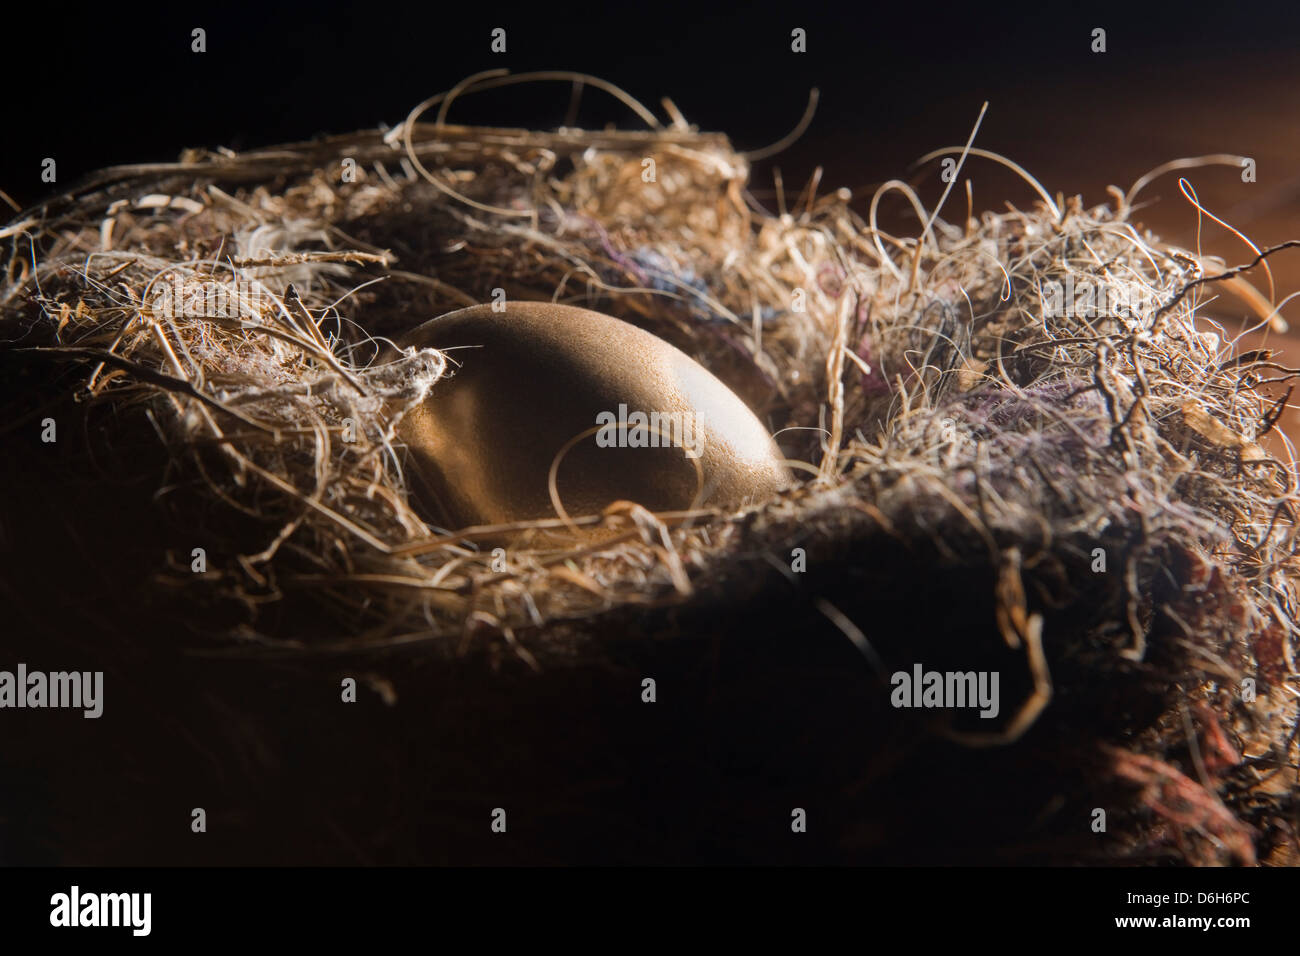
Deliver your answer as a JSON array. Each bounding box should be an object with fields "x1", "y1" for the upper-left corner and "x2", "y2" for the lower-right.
[{"x1": 10, "y1": 3, "x2": 1300, "y2": 411}]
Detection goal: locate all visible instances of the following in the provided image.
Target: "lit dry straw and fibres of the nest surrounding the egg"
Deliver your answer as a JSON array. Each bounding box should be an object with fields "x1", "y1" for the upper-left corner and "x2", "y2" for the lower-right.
[{"x1": 0, "y1": 74, "x2": 1300, "y2": 862}]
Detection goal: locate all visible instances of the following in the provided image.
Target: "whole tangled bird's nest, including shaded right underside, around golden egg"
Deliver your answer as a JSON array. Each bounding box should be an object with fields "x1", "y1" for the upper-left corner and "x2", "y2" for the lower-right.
[{"x1": 0, "y1": 78, "x2": 1297, "y2": 864}]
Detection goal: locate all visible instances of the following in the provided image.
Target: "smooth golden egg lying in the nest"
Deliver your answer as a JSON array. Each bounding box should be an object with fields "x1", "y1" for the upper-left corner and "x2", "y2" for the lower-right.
[{"x1": 398, "y1": 302, "x2": 790, "y2": 529}]
